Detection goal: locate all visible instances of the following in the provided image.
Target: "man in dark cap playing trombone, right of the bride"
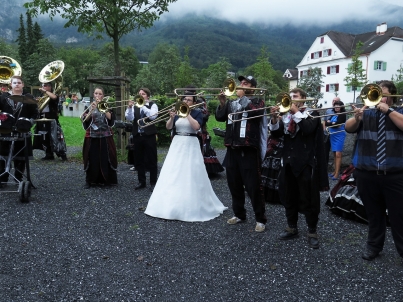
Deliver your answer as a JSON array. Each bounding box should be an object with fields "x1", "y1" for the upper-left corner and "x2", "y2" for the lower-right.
[{"x1": 215, "y1": 76, "x2": 267, "y2": 232}]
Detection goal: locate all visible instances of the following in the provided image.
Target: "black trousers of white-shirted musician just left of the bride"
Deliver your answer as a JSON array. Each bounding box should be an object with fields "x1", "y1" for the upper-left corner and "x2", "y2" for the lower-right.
[{"x1": 133, "y1": 134, "x2": 158, "y2": 185}]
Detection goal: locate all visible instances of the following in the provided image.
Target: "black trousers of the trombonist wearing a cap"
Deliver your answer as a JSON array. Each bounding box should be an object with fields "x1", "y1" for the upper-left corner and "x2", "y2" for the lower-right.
[{"x1": 225, "y1": 147, "x2": 267, "y2": 223}]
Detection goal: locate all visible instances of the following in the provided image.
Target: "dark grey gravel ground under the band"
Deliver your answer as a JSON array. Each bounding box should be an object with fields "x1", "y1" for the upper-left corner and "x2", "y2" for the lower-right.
[{"x1": 0, "y1": 148, "x2": 403, "y2": 302}]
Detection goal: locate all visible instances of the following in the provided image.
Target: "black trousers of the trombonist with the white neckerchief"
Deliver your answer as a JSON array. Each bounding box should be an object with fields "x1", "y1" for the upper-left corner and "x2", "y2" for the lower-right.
[{"x1": 279, "y1": 164, "x2": 320, "y2": 230}]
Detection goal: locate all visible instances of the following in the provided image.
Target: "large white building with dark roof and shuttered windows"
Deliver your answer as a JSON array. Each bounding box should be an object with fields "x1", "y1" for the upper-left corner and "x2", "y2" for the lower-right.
[{"x1": 284, "y1": 23, "x2": 403, "y2": 107}]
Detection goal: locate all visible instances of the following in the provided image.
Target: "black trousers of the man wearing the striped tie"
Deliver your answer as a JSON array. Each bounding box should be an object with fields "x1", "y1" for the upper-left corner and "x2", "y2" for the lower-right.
[{"x1": 354, "y1": 169, "x2": 403, "y2": 257}]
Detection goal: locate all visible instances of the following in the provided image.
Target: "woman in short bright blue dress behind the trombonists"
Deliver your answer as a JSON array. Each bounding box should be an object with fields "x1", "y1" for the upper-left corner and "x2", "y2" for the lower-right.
[{"x1": 325, "y1": 101, "x2": 346, "y2": 180}]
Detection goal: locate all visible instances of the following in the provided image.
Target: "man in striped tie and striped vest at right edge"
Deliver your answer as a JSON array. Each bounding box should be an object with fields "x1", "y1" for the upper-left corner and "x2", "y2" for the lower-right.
[{"x1": 346, "y1": 81, "x2": 403, "y2": 261}]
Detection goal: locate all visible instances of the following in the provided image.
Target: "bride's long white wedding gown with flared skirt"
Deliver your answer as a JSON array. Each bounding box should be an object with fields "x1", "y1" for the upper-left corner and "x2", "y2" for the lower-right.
[{"x1": 145, "y1": 118, "x2": 227, "y2": 221}]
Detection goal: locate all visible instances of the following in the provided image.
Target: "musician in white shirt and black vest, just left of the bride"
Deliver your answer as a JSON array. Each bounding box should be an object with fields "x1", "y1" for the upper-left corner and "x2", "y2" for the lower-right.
[{"x1": 126, "y1": 88, "x2": 158, "y2": 191}]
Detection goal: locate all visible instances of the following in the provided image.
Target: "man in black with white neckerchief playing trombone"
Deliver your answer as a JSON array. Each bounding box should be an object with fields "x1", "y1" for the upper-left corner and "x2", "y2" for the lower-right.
[{"x1": 269, "y1": 88, "x2": 329, "y2": 249}]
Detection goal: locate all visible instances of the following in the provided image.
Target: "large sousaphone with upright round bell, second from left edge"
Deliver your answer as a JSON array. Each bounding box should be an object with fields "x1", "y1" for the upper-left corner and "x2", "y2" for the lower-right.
[{"x1": 38, "y1": 60, "x2": 64, "y2": 112}]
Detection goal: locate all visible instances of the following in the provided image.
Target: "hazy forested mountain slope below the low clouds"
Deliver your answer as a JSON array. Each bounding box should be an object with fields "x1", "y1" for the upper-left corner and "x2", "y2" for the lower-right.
[{"x1": 0, "y1": 0, "x2": 403, "y2": 71}]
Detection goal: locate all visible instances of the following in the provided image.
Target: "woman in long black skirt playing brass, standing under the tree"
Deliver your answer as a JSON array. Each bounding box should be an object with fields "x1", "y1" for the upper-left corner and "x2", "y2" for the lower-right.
[{"x1": 82, "y1": 87, "x2": 118, "y2": 189}]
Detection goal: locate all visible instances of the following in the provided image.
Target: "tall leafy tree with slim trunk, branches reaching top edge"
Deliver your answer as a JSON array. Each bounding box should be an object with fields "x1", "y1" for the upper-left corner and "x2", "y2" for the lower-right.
[{"x1": 24, "y1": 0, "x2": 176, "y2": 76}]
